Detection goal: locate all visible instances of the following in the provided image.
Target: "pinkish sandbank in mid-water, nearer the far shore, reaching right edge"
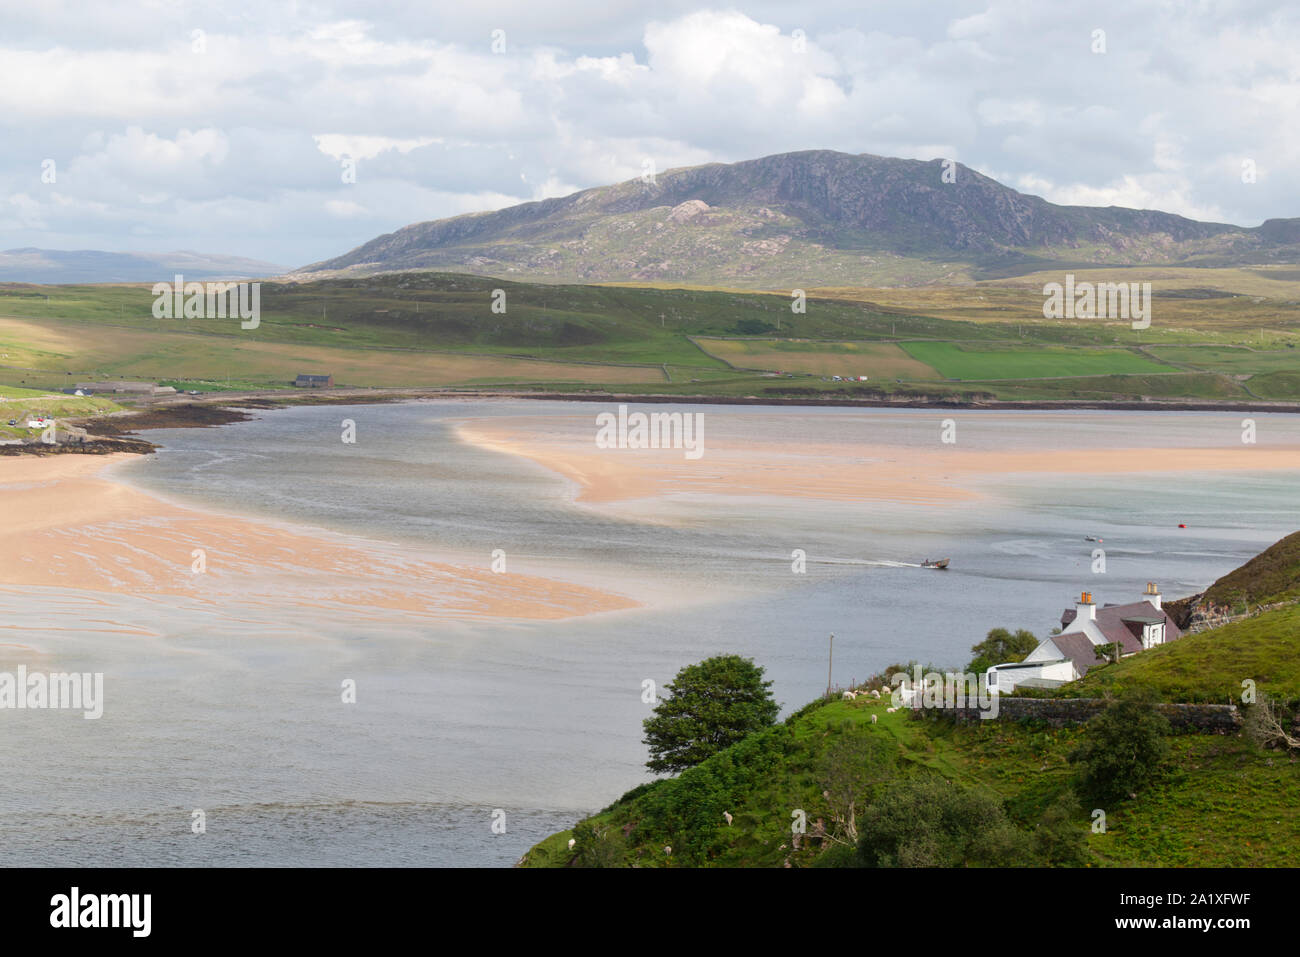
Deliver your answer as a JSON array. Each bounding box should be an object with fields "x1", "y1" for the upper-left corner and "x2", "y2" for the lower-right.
[{"x1": 458, "y1": 416, "x2": 1300, "y2": 506}]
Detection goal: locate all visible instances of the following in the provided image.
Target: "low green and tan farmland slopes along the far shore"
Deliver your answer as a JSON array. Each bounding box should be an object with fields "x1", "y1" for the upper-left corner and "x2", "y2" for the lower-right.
[{"x1": 0, "y1": 269, "x2": 1300, "y2": 400}]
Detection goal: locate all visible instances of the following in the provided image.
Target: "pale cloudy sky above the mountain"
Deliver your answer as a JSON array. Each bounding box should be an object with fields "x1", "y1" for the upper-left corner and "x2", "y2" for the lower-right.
[{"x1": 0, "y1": 0, "x2": 1300, "y2": 267}]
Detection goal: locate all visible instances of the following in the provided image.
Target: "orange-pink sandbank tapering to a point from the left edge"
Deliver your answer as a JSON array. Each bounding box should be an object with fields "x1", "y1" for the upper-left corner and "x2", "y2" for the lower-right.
[{"x1": 0, "y1": 454, "x2": 638, "y2": 619}]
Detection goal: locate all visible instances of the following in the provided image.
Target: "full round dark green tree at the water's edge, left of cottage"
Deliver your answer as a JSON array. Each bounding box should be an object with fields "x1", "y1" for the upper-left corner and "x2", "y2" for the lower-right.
[{"x1": 644, "y1": 654, "x2": 780, "y2": 774}]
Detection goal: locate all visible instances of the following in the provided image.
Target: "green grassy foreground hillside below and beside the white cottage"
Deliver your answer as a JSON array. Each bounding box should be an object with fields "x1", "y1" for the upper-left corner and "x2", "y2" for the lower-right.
[{"x1": 521, "y1": 533, "x2": 1300, "y2": 867}]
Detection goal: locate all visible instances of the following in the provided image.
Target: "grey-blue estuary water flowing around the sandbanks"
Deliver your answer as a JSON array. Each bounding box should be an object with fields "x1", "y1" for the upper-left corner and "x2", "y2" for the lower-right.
[{"x1": 0, "y1": 400, "x2": 1300, "y2": 866}]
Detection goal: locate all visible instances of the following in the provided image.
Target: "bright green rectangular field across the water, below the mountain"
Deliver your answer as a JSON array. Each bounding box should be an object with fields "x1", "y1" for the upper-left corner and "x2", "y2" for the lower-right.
[{"x1": 902, "y1": 342, "x2": 1174, "y2": 380}]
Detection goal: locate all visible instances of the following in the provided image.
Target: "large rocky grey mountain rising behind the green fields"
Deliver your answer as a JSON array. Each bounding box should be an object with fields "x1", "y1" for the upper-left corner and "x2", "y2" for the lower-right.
[{"x1": 299, "y1": 150, "x2": 1300, "y2": 289}]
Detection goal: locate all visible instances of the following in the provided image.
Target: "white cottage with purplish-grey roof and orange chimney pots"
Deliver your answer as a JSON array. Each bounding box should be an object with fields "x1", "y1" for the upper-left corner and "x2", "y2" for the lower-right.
[{"x1": 987, "y1": 581, "x2": 1183, "y2": 692}]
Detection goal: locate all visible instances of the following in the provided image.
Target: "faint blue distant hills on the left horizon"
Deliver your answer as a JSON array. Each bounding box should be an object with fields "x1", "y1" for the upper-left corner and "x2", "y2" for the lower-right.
[{"x1": 0, "y1": 247, "x2": 287, "y2": 285}]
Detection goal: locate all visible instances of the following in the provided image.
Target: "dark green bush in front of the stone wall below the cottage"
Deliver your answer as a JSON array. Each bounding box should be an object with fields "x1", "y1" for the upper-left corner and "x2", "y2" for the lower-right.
[{"x1": 1070, "y1": 690, "x2": 1169, "y2": 801}]
